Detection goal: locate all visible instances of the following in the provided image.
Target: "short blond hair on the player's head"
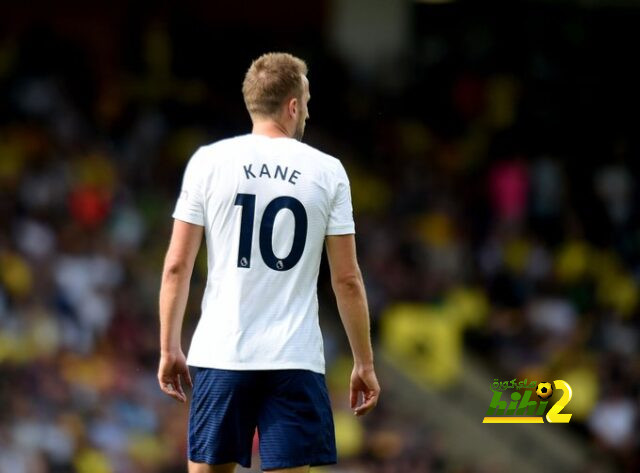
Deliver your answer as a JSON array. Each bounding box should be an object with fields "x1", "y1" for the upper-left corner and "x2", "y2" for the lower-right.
[{"x1": 242, "y1": 53, "x2": 307, "y2": 117}]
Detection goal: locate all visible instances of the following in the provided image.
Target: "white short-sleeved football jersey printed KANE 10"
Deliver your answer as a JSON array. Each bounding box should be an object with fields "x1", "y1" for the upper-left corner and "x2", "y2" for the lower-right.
[{"x1": 173, "y1": 134, "x2": 354, "y2": 373}]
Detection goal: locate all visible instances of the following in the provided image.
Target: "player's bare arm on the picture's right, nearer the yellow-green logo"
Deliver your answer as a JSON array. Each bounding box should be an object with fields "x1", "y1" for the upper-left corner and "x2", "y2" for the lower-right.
[{"x1": 326, "y1": 234, "x2": 380, "y2": 416}]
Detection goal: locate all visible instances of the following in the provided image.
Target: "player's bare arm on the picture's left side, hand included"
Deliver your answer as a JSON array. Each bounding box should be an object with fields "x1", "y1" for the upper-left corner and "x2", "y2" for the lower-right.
[{"x1": 158, "y1": 219, "x2": 203, "y2": 402}]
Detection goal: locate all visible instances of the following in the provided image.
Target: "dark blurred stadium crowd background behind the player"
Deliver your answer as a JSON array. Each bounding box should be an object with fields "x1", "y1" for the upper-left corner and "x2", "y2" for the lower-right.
[{"x1": 0, "y1": 0, "x2": 640, "y2": 473}]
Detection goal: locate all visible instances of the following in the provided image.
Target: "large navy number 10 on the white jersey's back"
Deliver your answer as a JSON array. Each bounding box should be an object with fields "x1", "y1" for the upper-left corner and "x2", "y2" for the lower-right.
[{"x1": 235, "y1": 194, "x2": 307, "y2": 271}]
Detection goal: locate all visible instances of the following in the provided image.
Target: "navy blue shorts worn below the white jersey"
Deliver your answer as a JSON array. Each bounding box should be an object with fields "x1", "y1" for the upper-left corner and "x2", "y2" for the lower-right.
[{"x1": 189, "y1": 368, "x2": 336, "y2": 470}]
